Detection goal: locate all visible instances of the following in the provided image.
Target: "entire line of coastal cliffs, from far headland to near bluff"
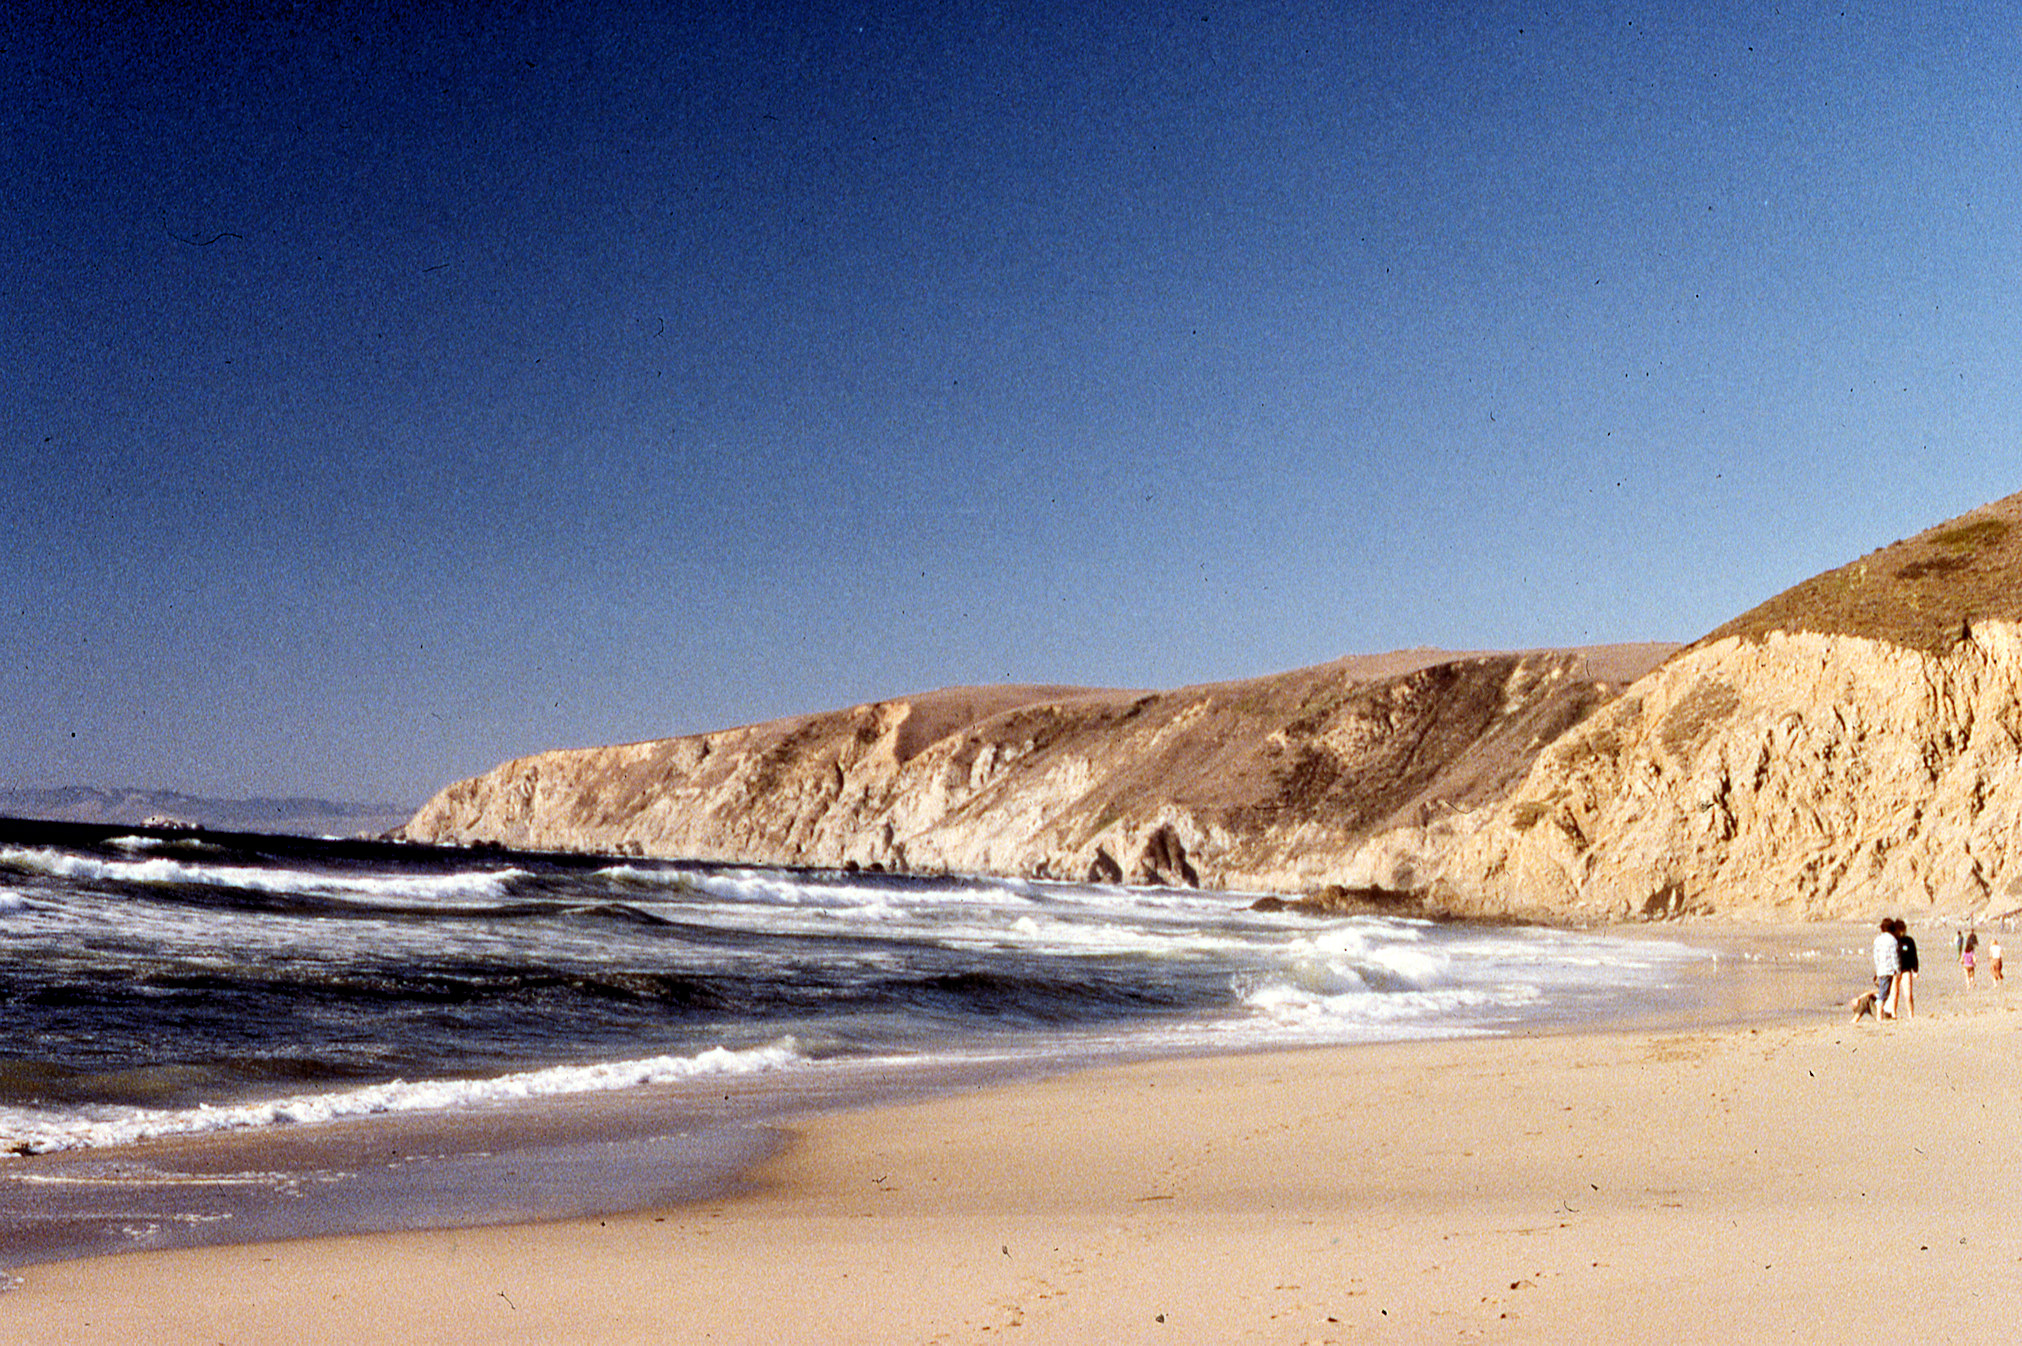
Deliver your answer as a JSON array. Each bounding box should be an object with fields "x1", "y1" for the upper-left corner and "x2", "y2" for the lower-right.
[{"x1": 402, "y1": 495, "x2": 2022, "y2": 920}]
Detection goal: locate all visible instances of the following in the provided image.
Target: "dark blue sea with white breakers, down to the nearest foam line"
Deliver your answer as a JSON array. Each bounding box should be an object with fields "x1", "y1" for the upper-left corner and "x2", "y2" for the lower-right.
[{"x1": 0, "y1": 837, "x2": 1722, "y2": 1150}]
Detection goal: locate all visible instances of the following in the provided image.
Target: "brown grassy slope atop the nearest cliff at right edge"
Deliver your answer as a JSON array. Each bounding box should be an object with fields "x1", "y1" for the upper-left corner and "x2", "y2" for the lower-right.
[{"x1": 1690, "y1": 493, "x2": 2022, "y2": 653}]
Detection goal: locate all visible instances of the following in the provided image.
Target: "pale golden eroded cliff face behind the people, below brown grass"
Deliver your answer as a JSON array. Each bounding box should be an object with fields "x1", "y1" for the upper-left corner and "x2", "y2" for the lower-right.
[{"x1": 1431, "y1": 620, "x2": 2022, "y2": 920}]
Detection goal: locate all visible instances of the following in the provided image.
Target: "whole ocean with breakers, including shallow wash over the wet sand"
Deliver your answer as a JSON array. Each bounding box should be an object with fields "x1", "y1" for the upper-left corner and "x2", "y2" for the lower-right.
[{"x1": 0, "y1": 821, "x2": 1771, "y2": 1263}]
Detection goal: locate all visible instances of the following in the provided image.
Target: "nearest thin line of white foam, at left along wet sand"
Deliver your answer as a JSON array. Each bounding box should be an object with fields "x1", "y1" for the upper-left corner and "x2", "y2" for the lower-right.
[{"x1": 0, "y1": 1037, "x2": 807, "y2": 1154}]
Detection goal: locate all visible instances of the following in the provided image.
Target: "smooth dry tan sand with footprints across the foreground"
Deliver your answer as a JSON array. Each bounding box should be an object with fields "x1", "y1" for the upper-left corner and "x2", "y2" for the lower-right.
[{"x1": 0, "y1": 960, "x2": 2022, "y2": 1346}]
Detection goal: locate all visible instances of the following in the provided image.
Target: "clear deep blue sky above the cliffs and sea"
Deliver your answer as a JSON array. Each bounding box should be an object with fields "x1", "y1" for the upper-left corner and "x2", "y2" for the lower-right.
[{"x1": 0, "y1": 0, "x2": 2022, "y2": 802}]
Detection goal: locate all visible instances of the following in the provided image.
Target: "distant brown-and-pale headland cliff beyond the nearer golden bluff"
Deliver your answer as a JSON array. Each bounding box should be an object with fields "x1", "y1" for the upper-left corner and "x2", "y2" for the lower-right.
[{"x1": 400, "y1": 645, "x2": 1672, "y2": 891}]
